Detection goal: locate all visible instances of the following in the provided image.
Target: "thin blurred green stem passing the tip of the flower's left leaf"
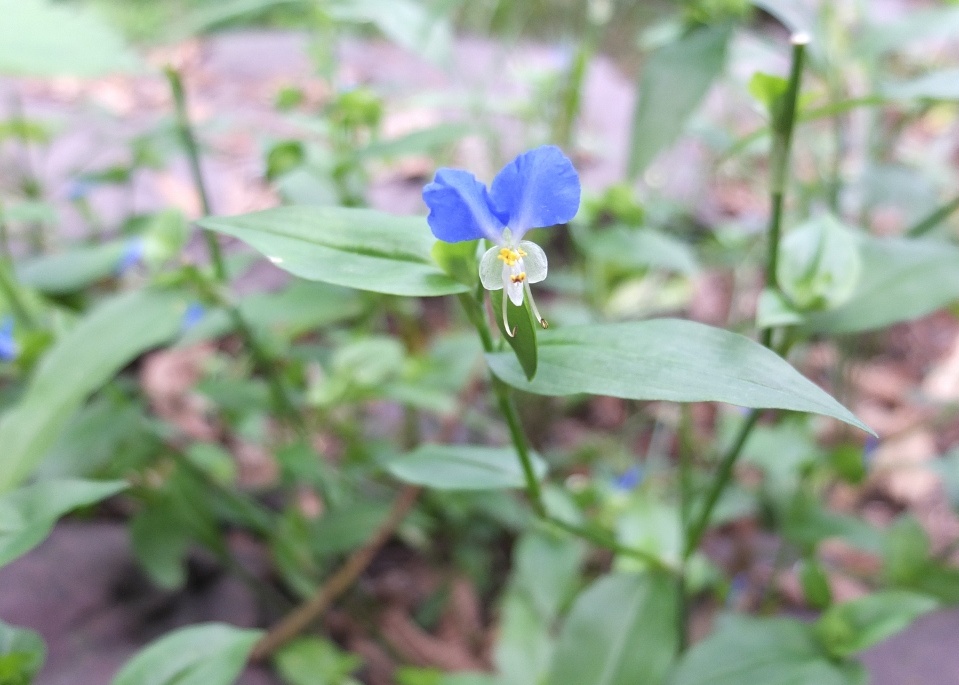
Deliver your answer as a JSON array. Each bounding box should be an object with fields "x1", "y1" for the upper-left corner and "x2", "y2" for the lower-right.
[{"x1": 166, "y1": 67, "x2": 307, "y2": 438}]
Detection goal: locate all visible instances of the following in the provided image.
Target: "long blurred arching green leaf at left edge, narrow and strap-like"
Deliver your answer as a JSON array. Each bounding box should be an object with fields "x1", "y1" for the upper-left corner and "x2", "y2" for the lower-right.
[{"x1": 0, "y1": 290, "x2": 185, "y2": 492}]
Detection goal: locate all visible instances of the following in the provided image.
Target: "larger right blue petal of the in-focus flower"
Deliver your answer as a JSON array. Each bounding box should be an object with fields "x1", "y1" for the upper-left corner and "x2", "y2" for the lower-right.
[{"x1": 490, "y1": 145, "x2": 580, "y2": 240}]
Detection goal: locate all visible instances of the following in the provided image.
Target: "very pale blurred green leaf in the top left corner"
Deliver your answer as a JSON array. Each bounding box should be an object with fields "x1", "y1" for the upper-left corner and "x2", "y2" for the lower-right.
[{"x1": 0, "y1": 0, "x2": 139, "y2": 77}]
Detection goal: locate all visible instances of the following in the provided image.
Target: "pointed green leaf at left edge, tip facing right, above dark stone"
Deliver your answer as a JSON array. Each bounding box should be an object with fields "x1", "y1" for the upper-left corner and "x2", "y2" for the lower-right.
[{"x1": 0, "y1": 480, "x2": 127, "y2": 566}]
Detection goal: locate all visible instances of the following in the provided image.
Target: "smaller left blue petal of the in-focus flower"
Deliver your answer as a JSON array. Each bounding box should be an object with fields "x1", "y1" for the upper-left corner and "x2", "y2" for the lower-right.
[{"x1": 423, "y1": 169, "x2": 504, "y2": 243}]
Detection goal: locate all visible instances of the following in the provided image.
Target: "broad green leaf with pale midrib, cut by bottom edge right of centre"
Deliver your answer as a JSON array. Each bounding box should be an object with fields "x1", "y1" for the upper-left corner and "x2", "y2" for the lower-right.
[{"x1": 547, "y1": 573, "x2": 679, "y2": 685}]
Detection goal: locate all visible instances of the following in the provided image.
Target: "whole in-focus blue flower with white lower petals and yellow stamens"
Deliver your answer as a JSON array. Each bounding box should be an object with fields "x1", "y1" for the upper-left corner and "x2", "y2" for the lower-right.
[{"x1": 423, "y1": 145, "x2": 580, "y2": 335}]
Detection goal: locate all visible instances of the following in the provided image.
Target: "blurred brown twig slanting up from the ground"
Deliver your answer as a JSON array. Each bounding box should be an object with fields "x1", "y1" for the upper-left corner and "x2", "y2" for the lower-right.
[{"x1": 250, "y1": 485, "x2": 421, "y2": 662}]
